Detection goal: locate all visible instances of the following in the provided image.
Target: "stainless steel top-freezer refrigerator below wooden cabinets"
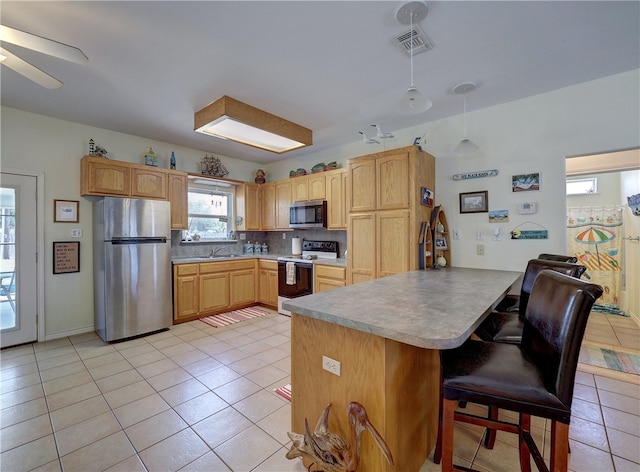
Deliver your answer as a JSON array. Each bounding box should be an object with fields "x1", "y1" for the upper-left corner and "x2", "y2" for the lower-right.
[{"x1": 93, "y1": 197, "x2": 173, "y2": 342}]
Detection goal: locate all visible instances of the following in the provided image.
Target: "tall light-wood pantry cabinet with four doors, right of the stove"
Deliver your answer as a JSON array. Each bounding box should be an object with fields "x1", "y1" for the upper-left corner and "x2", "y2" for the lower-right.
[{"x1": 347, "y1": 146, "x2": 435, "y2": 284}]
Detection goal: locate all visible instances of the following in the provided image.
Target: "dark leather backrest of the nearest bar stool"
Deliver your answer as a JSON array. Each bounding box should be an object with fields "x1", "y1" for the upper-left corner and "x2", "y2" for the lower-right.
[{"x1": 520, "y1": 269, "x2": 603, "y2": 408}]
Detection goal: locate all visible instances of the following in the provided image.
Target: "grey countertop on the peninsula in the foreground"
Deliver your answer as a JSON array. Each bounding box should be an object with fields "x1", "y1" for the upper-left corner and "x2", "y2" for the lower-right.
[{"x1": 283, "y1": 267, "x2": 520, "y2": 349}]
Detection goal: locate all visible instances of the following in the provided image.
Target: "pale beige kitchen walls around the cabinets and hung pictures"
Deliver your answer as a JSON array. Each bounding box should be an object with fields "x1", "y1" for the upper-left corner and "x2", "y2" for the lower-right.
[{"x1": 1, "y1": 70, "x2": 640, "y2": 338}]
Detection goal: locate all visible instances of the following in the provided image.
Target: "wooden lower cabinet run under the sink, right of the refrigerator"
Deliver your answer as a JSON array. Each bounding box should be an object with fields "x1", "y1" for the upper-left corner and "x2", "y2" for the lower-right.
[{"x1": 173, "y1": 259, "x2": 258, "y2": 323}]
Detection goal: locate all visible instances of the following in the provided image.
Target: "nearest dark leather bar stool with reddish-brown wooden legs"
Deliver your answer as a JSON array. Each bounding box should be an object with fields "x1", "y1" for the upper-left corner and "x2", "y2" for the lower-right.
[{"x1": 434, "y1": 269, "x2": 603, "y2": 472}]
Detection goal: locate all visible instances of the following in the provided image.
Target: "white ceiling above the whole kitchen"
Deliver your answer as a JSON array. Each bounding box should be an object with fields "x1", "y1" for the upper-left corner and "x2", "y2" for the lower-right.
[{"x1": 0, "y1": 0, "x2": 640, "y2": 163}]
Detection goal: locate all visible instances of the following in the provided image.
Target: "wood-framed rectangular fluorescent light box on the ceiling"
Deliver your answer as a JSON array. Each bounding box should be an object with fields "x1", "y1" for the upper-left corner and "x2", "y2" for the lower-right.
[{"x1": 194, "y1": 95, "x2": 313, "y2": 154}]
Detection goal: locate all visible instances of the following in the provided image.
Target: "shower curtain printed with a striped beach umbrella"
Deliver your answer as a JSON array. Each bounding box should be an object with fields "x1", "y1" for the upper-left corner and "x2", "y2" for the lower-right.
[{"x1": 567, "y1": 206, "x2": 624, "y2": 308}]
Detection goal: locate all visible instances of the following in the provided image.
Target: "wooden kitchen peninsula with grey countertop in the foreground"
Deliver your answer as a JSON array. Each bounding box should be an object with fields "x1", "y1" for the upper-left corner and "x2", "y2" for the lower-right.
[{"x1": 284, "y1": 267, "x2": 520, "y2": 471}]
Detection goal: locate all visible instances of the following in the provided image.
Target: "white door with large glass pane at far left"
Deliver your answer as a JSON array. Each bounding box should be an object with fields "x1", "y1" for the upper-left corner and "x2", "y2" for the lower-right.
[{"x1": 0, "y1": 172, "x2": 38, "y2": 347}]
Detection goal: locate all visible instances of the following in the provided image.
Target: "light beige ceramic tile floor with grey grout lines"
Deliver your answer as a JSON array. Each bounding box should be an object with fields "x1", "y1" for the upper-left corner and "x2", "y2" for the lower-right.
[{"x1": 0, "y1": 312, "x2": 640, "y2": 472}]
